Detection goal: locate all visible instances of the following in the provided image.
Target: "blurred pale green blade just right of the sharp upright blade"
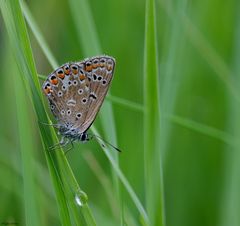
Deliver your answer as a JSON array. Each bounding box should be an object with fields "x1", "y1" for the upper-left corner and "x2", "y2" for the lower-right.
[{"x1": 161, "y1": 0, "x2": 186, "y2": 163}]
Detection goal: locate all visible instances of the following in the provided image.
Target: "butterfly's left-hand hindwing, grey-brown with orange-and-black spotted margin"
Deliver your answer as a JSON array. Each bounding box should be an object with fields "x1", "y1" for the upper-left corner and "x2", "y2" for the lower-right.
[{"x1": 42, "y1": 63, "x2": 89, "y2": 126}]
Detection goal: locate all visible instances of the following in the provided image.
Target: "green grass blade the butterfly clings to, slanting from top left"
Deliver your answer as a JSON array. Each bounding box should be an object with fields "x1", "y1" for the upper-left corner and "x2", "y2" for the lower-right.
[{"x1": 0, "y1": 0, "x2": 95, "y2": 225}]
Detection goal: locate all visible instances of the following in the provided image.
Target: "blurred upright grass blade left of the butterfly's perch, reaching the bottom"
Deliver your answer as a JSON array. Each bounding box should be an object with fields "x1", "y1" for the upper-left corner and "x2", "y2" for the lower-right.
[{"x1": 13, "y1": 67, "x2": 42, "y2": 226}]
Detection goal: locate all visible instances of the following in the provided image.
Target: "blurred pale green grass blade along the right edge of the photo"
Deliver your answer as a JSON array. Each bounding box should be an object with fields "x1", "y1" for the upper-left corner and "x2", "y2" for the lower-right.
[{"x1": 219, "y1": 4, "x2": 240, "y2": 226}]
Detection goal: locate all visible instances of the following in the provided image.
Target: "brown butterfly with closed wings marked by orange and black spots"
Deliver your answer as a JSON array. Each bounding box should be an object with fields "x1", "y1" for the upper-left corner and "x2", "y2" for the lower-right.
[{"x1": 42, "y1": 56, "x2": 115, "y2": 145}]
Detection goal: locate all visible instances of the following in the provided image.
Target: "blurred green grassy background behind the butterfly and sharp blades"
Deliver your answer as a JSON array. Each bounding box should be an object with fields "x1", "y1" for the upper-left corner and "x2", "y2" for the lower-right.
[{"x1": 0, "y1": 0, "x2": 240, "y2": 226}]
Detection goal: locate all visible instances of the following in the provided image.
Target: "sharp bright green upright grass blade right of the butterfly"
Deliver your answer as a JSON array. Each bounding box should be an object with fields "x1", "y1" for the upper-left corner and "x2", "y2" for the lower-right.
[{"x1": 144, "y1": 0, "x2": 164, "y2": 226}]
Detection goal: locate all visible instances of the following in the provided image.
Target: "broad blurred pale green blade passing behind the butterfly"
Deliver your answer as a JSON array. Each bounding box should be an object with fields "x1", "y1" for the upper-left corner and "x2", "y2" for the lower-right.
[{"x1": 69, "y1": 0, "x2": 124, "y2": 224}]
